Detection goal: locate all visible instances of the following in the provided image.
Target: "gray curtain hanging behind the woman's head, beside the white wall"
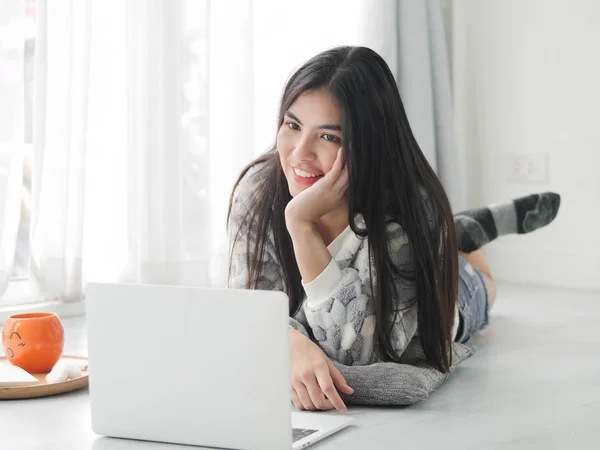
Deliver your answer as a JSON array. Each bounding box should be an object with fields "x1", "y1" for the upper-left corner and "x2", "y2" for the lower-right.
[{"x1": 362, "y1": 0, "x2": 464, "y2": 211}]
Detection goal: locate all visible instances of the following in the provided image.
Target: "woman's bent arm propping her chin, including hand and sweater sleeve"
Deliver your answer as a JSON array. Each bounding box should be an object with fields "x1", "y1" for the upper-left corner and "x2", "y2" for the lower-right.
[{"x1": 285, "y1": 149, "x2": 417, "y2": 365}]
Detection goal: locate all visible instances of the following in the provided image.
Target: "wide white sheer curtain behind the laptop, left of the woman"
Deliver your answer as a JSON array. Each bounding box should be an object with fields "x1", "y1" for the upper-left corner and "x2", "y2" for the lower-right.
[{"x1": 31, "y1": 0, "x2": 255, "y2": 301}]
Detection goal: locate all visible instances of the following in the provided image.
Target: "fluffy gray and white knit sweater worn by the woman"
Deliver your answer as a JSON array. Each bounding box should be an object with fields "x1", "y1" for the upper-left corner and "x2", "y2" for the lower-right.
[{"x1": 229, "y1": 168, "x2": 458, "y2": 365}]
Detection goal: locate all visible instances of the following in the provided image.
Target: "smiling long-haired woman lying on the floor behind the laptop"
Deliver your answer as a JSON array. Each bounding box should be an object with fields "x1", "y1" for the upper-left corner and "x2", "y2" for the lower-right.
[{"x1": 228, "y1": 47, "x2": 558, "y2": 412}]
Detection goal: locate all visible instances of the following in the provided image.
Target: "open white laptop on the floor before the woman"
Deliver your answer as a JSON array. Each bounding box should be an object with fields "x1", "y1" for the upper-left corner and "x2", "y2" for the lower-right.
[{"x1": 85, "y1": 283, "x2": 351, "y2": 450}]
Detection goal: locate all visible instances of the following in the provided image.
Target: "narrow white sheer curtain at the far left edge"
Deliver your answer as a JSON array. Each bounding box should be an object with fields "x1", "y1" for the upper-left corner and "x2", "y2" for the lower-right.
[{"x1": 0, "y1": 1, "x2": 25, "y2": 295}]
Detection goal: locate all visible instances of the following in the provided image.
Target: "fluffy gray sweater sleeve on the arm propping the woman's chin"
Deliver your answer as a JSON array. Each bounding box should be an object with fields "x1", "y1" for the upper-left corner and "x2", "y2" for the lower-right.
[{"x1": 304, "y1": 223, "x2": 417, "y2": 365}]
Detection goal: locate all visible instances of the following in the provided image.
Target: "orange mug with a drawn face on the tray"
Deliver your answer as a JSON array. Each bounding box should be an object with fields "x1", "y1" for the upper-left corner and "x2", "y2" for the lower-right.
[{"x1": 2, "y1": 312, "x2": 65, "y2": 373}]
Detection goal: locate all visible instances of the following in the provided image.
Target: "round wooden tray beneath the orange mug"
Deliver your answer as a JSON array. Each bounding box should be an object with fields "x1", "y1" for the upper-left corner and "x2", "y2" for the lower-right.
[{"x1": 0, "y1": 355, "x2": 89, "y2": 400}]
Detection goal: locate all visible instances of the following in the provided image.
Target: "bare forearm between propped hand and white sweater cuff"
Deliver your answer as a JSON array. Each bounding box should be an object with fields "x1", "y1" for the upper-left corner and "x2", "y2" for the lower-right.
[{"x1": 287, "y1": 221, "x2": 331, "y2": 283}]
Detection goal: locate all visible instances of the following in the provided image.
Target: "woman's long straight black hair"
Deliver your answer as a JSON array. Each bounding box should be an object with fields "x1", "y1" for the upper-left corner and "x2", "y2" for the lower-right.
[{"x1": 229, "y1": 47, "x2": 458, "y2": 372}]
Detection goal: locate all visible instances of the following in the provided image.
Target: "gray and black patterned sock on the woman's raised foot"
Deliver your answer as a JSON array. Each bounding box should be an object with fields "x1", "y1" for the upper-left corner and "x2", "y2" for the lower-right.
[{"x1": 454, "y1": 192, "x2": 560, "y2": 253}]
